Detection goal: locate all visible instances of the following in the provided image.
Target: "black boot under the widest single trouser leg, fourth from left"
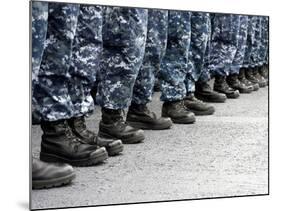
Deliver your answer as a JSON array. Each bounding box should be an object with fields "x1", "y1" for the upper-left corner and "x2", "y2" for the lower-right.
[{"x1": 99, "y1": 108, "x2": 145, "y2": 144}]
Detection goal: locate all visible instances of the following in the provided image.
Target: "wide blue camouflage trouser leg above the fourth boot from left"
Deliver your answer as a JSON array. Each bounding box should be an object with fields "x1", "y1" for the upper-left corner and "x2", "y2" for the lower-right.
[{"x1": 96, "y1": 7, "x2": 148, "y2": 110}]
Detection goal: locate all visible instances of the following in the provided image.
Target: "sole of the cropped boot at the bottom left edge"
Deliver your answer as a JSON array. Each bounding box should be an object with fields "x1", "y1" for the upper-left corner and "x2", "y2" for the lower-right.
[{"x1": 32, "y1": 172, "x2": 76, "y2": 189}]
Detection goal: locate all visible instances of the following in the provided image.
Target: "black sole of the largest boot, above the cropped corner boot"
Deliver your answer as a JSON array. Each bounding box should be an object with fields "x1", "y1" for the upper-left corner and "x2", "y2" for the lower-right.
[{"x1": 40, "y1": 148, "x2": 108, "y2": 167}]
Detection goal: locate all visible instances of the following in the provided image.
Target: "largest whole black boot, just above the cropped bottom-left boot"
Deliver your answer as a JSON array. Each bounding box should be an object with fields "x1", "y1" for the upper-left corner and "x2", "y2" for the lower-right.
[{"x1": 40, "y1": 120, "x2": 108, "y2": 166}]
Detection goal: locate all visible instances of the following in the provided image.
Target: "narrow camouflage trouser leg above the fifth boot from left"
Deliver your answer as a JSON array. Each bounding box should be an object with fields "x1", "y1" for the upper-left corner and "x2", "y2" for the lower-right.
[{"x1": 132, "y1": 9, "x2": 168, "y2": 104}]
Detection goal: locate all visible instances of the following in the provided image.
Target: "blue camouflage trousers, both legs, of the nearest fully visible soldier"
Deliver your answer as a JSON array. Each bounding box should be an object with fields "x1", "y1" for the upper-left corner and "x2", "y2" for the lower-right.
[{"x1": 33, "y1": 3, "x2": 102, "y2": 121}]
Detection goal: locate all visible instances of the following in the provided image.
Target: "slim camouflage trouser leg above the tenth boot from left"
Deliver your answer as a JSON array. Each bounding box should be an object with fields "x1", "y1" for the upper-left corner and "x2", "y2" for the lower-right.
[{"x1": 230, "y1": 15, "x2": 248, "y2": 74}]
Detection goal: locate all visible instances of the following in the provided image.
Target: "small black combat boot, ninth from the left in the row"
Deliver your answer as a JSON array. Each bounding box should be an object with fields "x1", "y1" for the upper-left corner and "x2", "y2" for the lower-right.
[{"x1": 214, "y1": 76, "x2": 239, "y2": 99}]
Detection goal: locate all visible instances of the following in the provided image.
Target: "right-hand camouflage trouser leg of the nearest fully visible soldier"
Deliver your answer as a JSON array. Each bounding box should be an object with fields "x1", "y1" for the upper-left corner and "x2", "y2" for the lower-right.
[{"x1": 68, "y1": 5, "x2": 103, "y2": 116}]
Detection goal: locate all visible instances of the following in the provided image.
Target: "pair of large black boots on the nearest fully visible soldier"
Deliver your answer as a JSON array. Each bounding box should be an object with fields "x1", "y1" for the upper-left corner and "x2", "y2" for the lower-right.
[{"x1": 40, "y1": 117, "x2": 123, "y2": 166}]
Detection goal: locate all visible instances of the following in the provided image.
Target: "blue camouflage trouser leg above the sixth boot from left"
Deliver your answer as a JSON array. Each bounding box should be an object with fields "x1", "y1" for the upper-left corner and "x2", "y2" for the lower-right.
[{"x1": 159, "y1": 11, "x2": 191, "y2": 101}]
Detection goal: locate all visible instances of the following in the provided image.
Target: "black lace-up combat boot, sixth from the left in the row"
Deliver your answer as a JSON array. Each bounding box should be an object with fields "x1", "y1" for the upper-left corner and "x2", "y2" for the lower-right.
[{"x1": 162, "y1": 100, "x2": 195, "y2": 124}]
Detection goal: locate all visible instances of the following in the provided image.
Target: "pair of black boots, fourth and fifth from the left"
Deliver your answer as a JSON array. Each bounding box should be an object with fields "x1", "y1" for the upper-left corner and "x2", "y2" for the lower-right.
[{"x1": 99, "y1": 104, "x2": 172, "y2": 144}]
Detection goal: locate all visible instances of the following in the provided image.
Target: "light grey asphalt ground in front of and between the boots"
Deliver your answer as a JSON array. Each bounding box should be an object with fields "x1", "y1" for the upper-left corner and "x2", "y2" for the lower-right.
[{"x1": 31, "y1": 85, "x2": 268, "y2": 209}]
